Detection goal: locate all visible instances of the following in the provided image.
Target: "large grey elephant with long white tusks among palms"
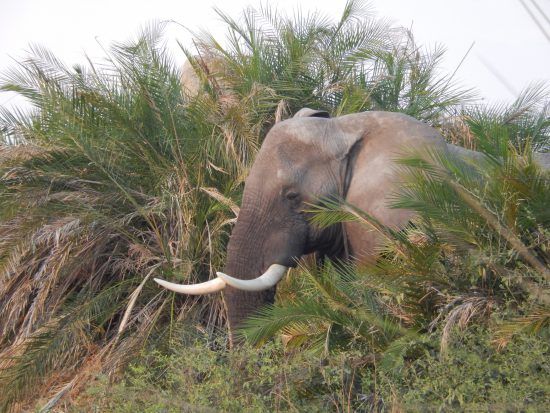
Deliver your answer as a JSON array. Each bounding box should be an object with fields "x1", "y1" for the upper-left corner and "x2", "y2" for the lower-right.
[{"x1": 155, "y1": 108, "x2": 544, "y2": 340}]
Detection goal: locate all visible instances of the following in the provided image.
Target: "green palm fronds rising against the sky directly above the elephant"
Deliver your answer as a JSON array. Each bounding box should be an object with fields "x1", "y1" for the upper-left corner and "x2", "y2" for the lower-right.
[{"x1": 187, "y1": 1, "x2": 469, "y2": 121}]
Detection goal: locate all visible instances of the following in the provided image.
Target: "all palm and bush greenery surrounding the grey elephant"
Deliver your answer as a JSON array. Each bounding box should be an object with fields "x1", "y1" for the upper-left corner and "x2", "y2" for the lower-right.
[{"x1": 0, "y1": 1, "x2": 550, "y2": 412}]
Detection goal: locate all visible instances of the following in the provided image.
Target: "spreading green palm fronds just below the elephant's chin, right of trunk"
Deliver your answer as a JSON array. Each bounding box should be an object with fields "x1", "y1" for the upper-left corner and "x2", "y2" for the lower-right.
[{"x1": 242, "y1": 262, "x2": 410, "y2": 352}]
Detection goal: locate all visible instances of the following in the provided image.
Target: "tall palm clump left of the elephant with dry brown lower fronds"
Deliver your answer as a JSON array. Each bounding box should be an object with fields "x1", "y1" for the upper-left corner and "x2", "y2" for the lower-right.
[{"x1": 0, "y1": 23, "x2": 242, "y2": 403}]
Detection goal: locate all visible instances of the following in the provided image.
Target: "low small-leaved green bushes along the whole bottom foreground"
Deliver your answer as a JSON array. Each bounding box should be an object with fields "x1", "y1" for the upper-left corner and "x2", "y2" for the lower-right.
[{"x1": 69, "y1": 328, "x2": 550, "y2": 413}]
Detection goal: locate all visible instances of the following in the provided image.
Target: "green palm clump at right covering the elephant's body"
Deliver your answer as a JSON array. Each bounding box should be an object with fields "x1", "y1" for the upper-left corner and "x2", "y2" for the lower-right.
[{"x1": 307, "y1": 89, "x2": 550, "y2": 351}]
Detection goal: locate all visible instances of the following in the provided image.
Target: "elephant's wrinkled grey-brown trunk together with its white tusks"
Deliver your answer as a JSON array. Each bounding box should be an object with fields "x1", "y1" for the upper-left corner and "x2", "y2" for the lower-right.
[{"x1": 155, "y1": 191, "x2": 307, "y2": 343}]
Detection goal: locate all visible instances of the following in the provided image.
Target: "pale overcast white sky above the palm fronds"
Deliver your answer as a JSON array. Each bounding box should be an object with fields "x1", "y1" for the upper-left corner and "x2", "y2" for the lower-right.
[{"x1": 0, "y1": 0, "x2": 550, "y2": 105}]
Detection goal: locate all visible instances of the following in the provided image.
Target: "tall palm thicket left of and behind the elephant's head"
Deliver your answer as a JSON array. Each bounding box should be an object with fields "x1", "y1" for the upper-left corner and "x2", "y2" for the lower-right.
[{"x1": 0, "y1": 1, "x2": 472, "y2": 409}]
